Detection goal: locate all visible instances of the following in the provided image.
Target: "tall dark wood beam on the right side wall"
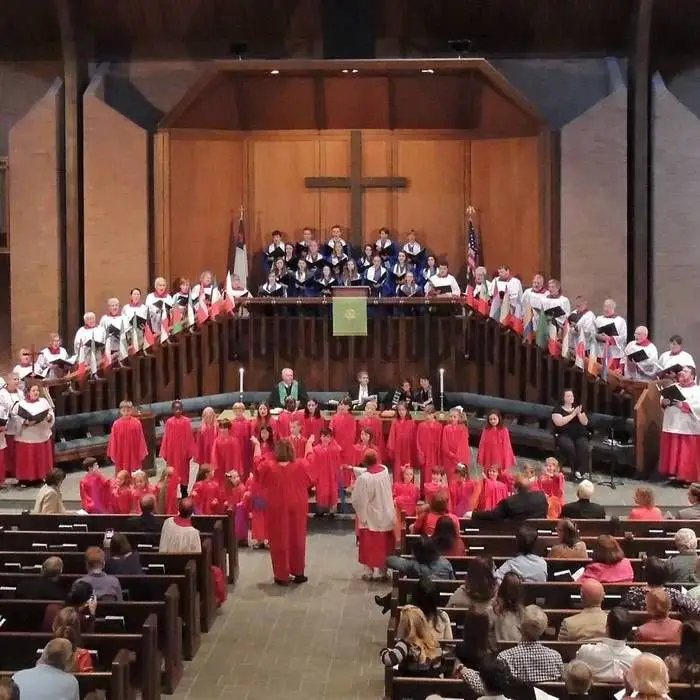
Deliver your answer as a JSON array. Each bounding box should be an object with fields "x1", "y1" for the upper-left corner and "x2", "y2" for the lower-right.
[{"x1": 627, "y1": 0, "x2": 654, "y2": 329}]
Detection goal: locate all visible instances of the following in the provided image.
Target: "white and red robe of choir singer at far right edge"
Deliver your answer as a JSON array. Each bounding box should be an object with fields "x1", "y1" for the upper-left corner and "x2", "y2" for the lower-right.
[{"x1": 659, "y1": 384, "x2": 700, "y2": 483}]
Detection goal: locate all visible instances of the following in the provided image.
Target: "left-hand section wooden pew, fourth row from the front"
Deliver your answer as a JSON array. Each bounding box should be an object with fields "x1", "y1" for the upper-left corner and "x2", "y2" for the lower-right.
[{"x1": 0, "y1": 584, "x2": 183, "y2": 693}]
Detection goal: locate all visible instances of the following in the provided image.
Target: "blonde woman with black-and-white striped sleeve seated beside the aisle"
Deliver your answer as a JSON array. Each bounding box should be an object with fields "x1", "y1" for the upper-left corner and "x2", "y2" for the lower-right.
[{"x1": 379, "y1": 605, "x2": 443, "y2": 677}]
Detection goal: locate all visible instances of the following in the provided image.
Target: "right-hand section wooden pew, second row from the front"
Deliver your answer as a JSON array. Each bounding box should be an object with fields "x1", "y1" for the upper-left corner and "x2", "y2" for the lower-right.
[{"x1": 401, "y1": 534, "x2": 678, "y2": 559}]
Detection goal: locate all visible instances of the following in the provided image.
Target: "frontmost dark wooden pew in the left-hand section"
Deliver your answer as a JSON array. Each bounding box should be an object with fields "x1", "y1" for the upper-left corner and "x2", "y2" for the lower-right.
[{"x1": 0, "y1": 513, "x2": 238, "y2": 583}]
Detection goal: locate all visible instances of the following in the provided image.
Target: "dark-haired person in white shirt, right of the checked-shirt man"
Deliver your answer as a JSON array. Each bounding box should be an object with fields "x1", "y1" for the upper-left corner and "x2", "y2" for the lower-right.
[{"x1": 576, "y1": 607, "x2": 641, "y2": 683}]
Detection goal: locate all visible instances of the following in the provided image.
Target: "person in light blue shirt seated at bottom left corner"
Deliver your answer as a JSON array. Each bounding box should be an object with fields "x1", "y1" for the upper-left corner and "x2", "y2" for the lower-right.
[{"x1": 12, "y1": 638, "x2": 80, "y2": 700}]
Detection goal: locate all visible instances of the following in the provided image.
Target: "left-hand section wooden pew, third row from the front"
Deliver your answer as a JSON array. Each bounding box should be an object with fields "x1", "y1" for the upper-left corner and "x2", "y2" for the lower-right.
[{"x1": 0, "y1": 561, "x2": 201, "y2": 661}]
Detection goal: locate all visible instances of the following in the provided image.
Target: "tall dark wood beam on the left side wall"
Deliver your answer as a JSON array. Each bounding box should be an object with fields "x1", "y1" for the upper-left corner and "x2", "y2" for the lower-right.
[{"x1": 54, "y1": 0, "x2": 88, "y2": 338}]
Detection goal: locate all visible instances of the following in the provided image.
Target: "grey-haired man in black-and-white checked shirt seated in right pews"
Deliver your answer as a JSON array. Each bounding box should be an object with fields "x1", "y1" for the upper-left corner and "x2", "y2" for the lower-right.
[{"x1": 496, "y1": 605, "x2": 564, "y2": 683}]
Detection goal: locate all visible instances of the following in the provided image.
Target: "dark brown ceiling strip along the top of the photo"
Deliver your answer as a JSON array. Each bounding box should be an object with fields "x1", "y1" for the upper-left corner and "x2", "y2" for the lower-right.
[{"x1": 0, "y1": 0, "x2": 700, "y2": 65}]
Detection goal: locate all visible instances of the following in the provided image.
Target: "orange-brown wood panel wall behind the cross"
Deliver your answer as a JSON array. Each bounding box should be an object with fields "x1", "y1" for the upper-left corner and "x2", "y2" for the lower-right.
[{"x1": 161, "y1": 129, "x2": 548, "y2": 288}]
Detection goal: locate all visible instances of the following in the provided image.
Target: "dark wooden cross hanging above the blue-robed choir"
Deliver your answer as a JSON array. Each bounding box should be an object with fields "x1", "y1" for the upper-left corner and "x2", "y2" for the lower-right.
[{"x1": 304, "y1": 131, "x2": 408, "y2": 248}]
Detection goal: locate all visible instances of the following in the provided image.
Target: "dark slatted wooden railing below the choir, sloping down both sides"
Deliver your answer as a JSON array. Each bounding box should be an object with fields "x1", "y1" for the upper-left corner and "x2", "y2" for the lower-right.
[{"x1": 45, "y1": 299, "x2": 636, "y2": 417}]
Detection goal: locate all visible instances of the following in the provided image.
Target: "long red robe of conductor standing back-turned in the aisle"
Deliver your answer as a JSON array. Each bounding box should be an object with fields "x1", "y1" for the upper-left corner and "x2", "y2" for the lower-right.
[{"x1": 256, "y1": 458, "x2": 313, "y2": 581}]
